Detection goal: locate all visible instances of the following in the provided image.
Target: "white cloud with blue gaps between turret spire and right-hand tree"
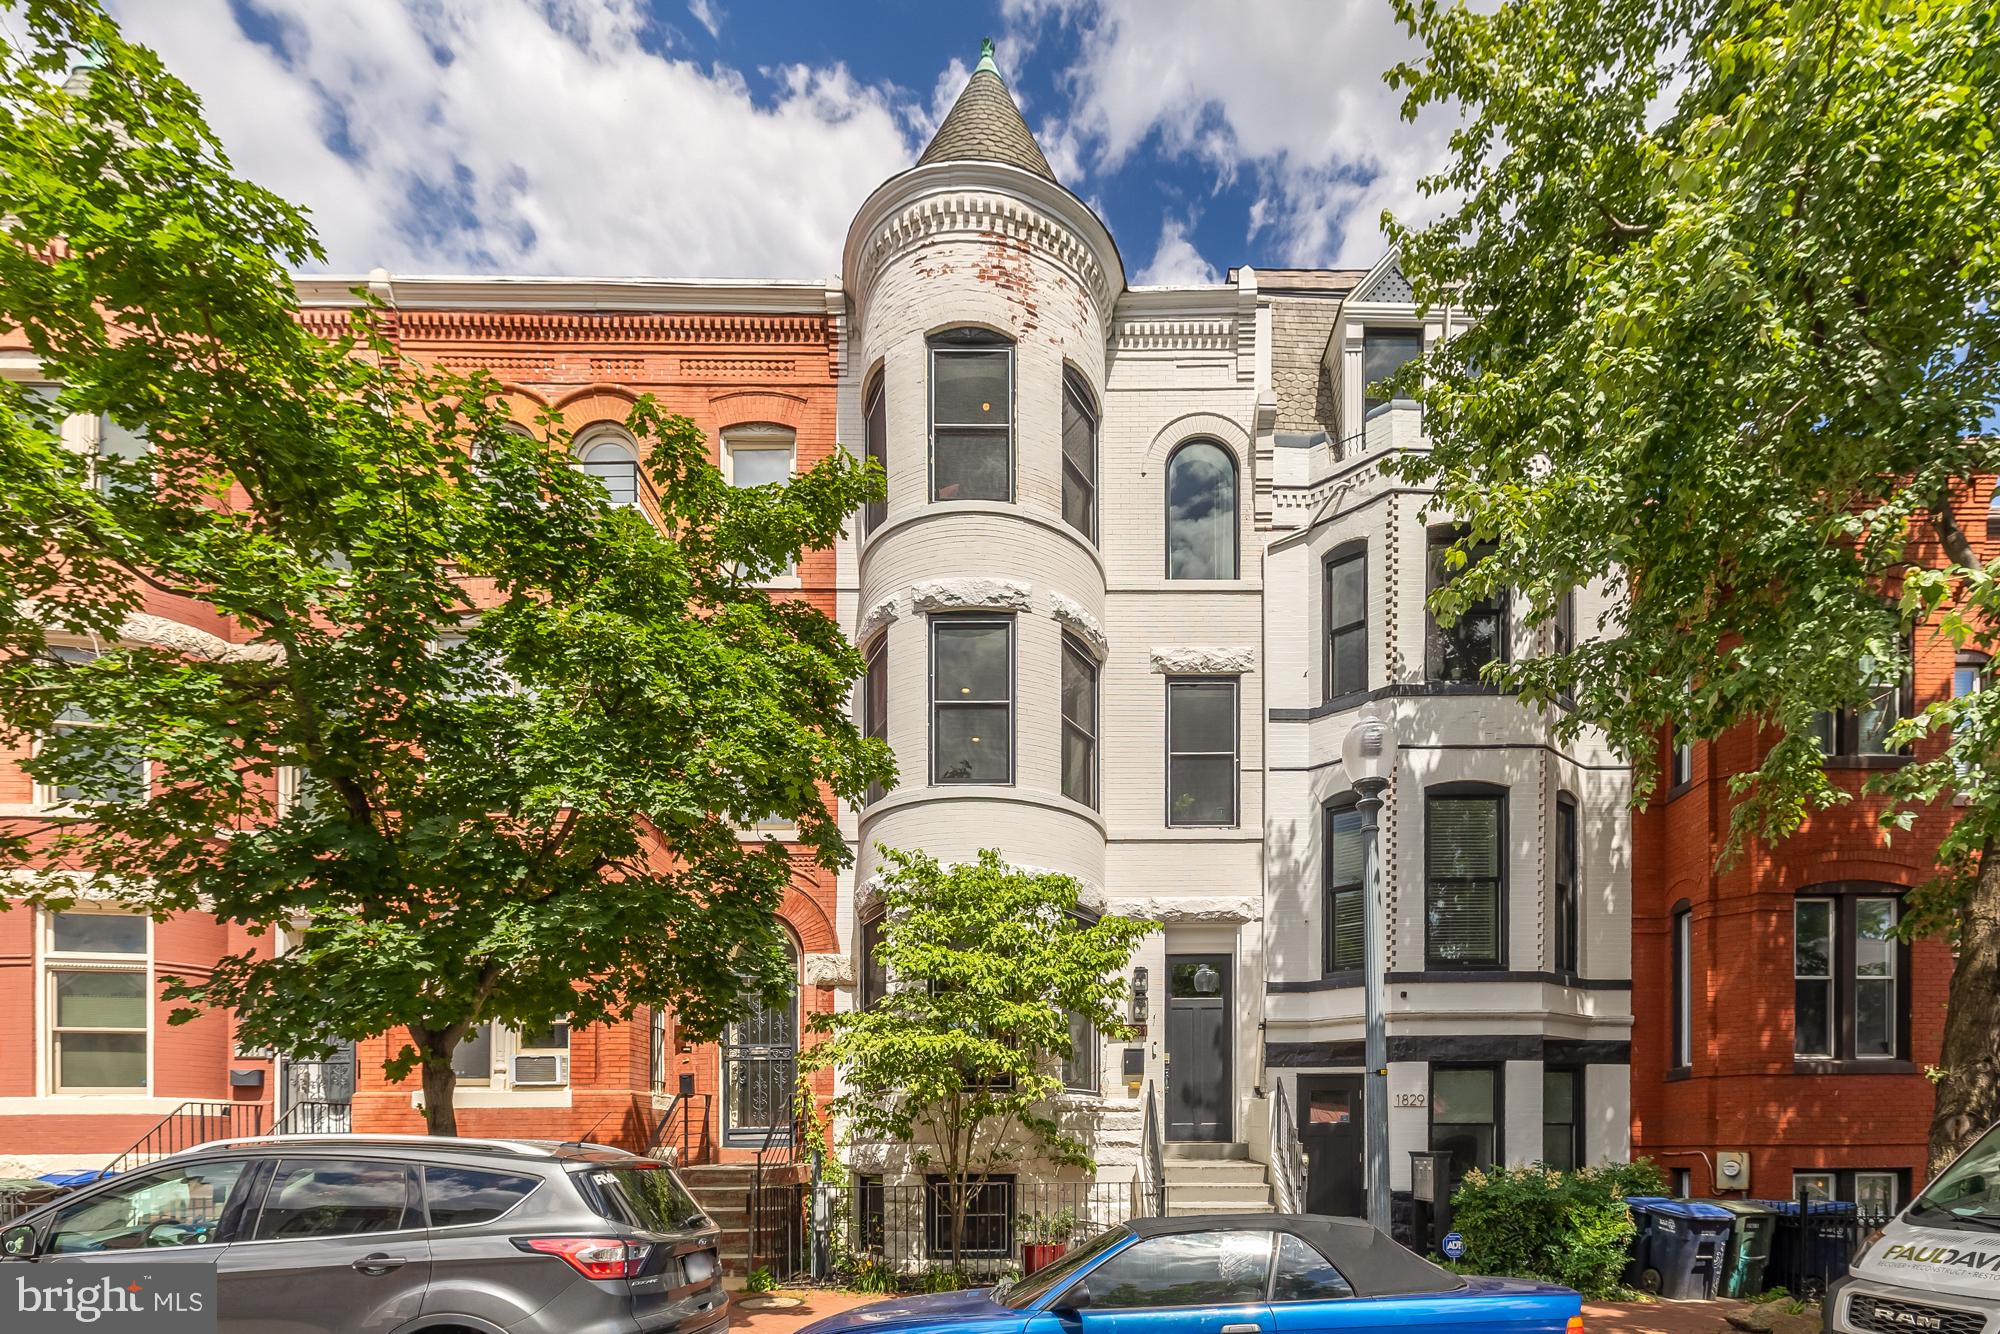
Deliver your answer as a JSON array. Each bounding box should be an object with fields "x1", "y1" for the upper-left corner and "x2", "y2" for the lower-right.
[{"x1": 1004, "y1": 0, "x2": 1450, "y2": 266}]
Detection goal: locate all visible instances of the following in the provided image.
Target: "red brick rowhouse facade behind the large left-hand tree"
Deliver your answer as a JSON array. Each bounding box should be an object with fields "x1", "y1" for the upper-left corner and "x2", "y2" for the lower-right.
[{"x1": 0, "y1": 276, "x2": 840, "y2": 1176}]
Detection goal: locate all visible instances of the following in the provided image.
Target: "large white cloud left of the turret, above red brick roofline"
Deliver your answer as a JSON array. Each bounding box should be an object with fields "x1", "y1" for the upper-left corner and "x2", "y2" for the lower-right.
[{"x1": 116, "y1": 0, "x2": 912, "y2": 278}]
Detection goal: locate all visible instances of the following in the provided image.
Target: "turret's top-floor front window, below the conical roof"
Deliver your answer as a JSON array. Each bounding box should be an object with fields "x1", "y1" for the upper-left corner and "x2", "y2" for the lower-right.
[{"x1": 930, "y1": 328, "x2": 1014, "y2": 500}]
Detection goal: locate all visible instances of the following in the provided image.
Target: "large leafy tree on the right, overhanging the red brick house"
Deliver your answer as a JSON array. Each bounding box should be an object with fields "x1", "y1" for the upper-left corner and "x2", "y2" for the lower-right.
[{"x1": 1390, "y1": 0, "x2": 2000, "y2": 1162}]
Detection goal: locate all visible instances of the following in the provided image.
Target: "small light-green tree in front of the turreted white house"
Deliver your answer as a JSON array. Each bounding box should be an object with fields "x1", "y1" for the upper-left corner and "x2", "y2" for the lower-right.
[{"x1": 800, "y1": 848, "x2": 1156, "y2": 1268}]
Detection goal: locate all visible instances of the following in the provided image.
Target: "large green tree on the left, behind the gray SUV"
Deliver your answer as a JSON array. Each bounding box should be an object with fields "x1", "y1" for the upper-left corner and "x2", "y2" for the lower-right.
[{"x1": 0, "y1": 0, "x2": 892, "y2": 1134}]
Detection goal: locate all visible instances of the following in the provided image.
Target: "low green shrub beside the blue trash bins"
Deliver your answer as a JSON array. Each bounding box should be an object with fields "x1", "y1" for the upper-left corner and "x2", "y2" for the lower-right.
[{"x1": 1452, "y1": 1160, "x2": 1664, "y2": 1298}]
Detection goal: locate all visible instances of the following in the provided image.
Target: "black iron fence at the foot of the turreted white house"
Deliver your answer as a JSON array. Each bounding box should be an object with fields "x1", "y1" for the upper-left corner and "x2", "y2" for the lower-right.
[{"x1": 802, "y1": 1176, "x2": 1160, "y2": 1280}]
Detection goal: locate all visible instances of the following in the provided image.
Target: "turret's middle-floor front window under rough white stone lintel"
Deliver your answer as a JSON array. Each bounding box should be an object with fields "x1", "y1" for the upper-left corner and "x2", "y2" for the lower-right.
[{"x1": 930, "y1": 616, "x2": 1014, "y2": 784}]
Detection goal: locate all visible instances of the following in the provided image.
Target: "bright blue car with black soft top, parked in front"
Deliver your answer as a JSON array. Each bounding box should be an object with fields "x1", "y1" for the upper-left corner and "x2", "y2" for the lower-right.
[{"x1": 800, "y1": 1214, "x2": 1584, "y2": 1334}]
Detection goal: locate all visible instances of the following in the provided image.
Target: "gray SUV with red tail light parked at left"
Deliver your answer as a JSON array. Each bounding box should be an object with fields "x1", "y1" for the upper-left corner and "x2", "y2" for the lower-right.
[{"x1": 0, "y1": 1134, "x2": 728, "y2": 1334}]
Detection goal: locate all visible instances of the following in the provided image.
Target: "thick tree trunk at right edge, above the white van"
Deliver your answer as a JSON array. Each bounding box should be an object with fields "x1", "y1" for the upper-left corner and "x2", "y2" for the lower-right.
[{"x1": 1930, "y1": 840, "x2": 2000, "y2": 1176}]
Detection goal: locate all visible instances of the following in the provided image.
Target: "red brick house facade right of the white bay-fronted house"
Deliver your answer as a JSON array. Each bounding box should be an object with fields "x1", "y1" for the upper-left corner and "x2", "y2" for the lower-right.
[{"x1": 1632, "y1": 486, "x2": 1988, "y2": 1202}]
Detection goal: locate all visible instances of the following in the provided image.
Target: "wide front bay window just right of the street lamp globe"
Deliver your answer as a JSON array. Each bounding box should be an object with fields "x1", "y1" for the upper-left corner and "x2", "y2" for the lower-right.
[{"x1": 1424, "y1": 786, "x2": 1506, "y2": 968}]
